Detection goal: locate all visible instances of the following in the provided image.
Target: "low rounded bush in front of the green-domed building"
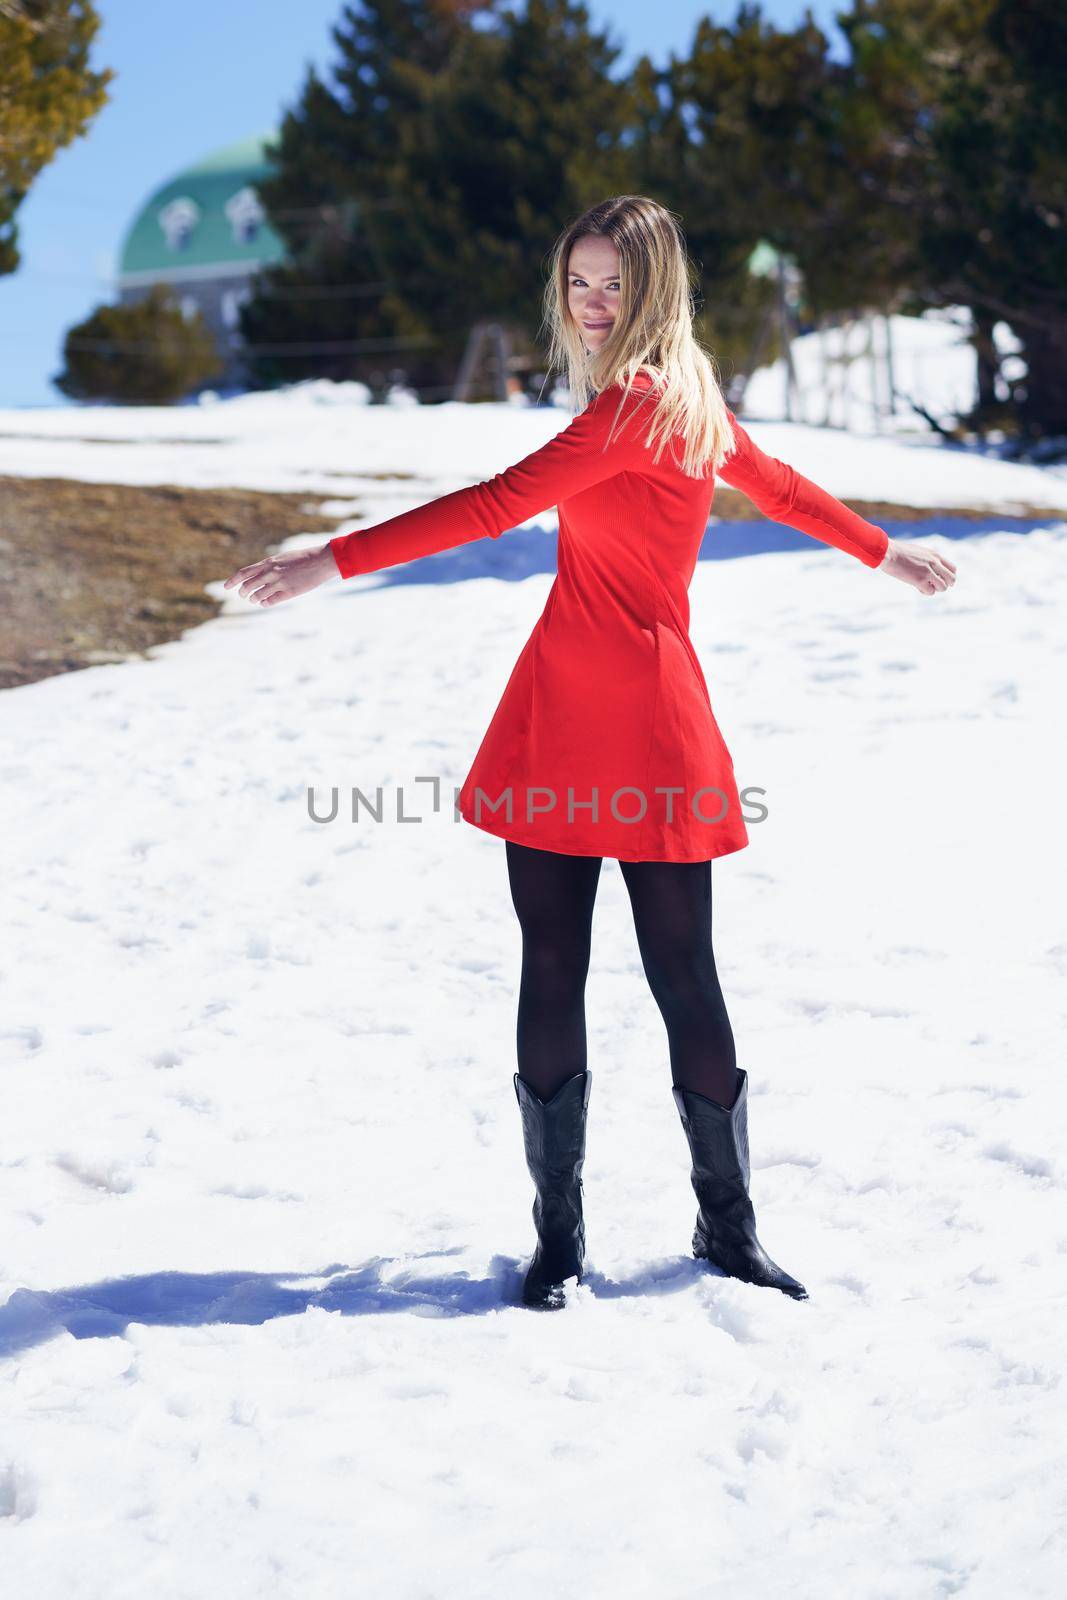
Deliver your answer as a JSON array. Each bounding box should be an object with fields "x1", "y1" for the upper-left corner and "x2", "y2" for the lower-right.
[{"x1": 53, "y1": 283, "x2": 224, "y2": 405}]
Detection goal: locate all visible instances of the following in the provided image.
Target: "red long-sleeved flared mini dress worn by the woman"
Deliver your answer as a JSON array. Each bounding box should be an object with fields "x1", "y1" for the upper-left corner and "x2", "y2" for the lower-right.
[{"x1": 330, "y1": 373, "x2": 888, "y2": 861}]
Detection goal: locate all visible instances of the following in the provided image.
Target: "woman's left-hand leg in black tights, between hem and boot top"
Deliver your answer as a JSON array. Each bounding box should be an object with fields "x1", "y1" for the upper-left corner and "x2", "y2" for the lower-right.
[{"x1": 506, "y1": 838, "x2": 601, "y2": 1101}]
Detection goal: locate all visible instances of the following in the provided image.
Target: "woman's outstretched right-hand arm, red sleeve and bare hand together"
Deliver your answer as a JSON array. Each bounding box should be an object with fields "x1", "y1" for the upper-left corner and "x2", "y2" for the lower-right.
[{"x1": 718, "y1": 411, "x2": 955, "y2": 594}]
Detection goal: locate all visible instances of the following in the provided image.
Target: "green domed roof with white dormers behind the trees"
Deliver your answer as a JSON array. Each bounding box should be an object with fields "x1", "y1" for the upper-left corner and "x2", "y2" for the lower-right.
[{"x1": 118, "y1": 133, "x2": 286, "y2": 283}]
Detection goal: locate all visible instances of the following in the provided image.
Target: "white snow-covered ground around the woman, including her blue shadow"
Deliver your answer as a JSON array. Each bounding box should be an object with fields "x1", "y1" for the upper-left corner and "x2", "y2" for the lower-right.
[{"x1": 0, "y1": 371, "x2": 1067, "y2": 1600}]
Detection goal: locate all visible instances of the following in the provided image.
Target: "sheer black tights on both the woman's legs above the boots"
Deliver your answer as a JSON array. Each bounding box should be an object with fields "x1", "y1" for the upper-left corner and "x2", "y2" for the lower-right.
[{"x1": 506, "y1": 840, "x2": 737, "y2": 1106}]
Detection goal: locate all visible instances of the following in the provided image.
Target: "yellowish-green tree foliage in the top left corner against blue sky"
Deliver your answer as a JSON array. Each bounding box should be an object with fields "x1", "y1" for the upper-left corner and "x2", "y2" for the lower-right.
[{"x1": 0, "y1": 0, "x2": 115, "y2": 275}]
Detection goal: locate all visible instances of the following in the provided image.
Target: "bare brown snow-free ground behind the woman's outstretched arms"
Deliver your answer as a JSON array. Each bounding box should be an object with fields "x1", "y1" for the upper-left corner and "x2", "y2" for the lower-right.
[{"x1": 0, "y1": 477, "x2": 1048, "y2": 688}]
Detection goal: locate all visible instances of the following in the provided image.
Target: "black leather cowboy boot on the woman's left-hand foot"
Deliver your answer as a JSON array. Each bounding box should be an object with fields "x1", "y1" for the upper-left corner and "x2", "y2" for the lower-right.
[{"x1": 515, "y1": 1072, "x2": 592, "y2": 1310}]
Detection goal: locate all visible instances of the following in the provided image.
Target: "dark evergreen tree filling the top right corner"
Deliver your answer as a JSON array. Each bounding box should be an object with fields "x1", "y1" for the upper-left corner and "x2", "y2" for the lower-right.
[{"x1": 838, "y1": 0, "x2": 1067, "y2": 440}]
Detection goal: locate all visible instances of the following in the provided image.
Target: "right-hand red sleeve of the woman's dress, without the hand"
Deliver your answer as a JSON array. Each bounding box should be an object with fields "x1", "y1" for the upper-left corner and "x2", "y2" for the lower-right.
[{"x1": 717, "y1": 411, "x2": 889, "y2": 566}]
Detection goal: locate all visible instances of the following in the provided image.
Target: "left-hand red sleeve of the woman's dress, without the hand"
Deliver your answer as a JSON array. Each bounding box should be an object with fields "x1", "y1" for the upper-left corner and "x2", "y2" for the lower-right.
[{"x1": 330, "y1": 384, "x2": 648, "y2": 578}]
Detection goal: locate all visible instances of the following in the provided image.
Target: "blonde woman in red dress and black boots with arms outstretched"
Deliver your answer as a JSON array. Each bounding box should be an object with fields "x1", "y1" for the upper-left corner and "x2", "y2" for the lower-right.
[{"x1": 226, "y1": 195, "x2": 955, "y2": 1309}]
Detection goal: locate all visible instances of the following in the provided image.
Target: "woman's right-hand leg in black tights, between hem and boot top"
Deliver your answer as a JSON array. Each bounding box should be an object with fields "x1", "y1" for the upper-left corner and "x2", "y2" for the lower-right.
[{"x1": 619, "y1": 861, "x2": 737, "y2": 1109}]
